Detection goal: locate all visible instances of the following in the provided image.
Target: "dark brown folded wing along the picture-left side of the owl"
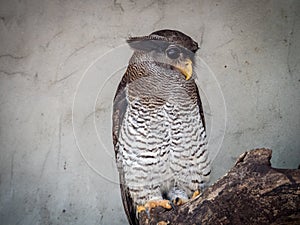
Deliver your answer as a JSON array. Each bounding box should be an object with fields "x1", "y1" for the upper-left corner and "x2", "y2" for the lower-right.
[{"x1": 112, "y1": 72, "x2": 138, "y2": 225}]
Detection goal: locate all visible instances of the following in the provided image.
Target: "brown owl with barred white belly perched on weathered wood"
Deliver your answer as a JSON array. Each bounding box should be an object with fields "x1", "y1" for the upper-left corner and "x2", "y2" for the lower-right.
[{"x1": 112, "y1": 30, "x2": 211, "y2": 224}]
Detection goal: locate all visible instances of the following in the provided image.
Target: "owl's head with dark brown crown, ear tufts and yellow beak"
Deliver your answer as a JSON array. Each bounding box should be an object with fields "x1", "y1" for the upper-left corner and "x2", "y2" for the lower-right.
[{"x1": 127, "y1": 30, "x2": 199, "y2": 80}]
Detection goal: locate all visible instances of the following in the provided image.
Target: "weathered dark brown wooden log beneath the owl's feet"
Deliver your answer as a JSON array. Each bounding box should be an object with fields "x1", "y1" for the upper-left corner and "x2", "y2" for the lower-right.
[{"x1": 140, "y1": 149, "x2": 300, "y2": 225}]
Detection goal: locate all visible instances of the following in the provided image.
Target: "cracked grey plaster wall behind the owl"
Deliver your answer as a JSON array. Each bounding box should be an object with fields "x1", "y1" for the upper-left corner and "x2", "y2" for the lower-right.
[{"x1": 0, "y1": 0, "x2": 300, "y2": 225}]
